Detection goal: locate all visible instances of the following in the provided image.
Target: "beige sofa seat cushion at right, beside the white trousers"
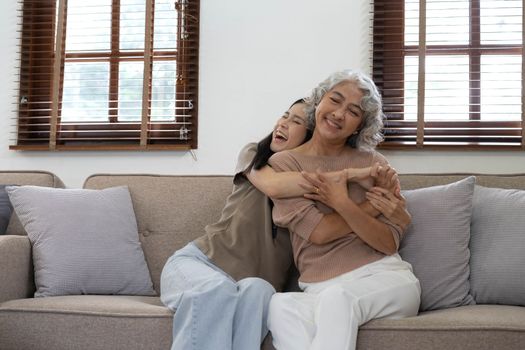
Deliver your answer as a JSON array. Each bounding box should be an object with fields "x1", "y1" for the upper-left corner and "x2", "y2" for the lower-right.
[{"x1": 357, "y1": 305, "x2": 525, "y2": 350}]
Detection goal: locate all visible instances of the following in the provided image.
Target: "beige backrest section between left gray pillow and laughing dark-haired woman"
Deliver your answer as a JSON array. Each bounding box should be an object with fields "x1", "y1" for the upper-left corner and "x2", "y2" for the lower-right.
[{"x1": 84, "y1": 174, "x2": 232, "y2": 293}]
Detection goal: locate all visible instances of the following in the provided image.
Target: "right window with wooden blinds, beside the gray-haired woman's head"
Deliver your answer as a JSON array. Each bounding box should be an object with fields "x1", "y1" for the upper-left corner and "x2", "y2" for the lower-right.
[{"x1": 373, "y1": 0, "x2": 525, "y2": 149}]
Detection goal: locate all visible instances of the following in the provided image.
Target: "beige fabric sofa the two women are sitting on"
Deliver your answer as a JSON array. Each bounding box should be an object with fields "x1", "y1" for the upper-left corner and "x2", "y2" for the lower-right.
[{"x1": 0, "y1": 171, "x2": 525, "y2": 350}]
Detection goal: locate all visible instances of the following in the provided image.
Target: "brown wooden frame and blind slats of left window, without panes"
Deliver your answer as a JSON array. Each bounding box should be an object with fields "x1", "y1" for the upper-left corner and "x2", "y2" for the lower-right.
[{"x1": 9, "y1": 0, "x2": 200, "y2": 151}]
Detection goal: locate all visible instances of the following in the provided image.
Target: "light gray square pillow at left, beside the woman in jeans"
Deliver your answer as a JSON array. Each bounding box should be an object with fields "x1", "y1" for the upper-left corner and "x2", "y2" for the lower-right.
[{"x1": 6, "y1": 186, "x2": 155, "y2": 297}]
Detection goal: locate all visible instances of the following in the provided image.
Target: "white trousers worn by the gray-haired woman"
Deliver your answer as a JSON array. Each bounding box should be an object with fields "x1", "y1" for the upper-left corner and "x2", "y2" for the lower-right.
[{"x1": 268, "y1": 254, "x2": 421, "y2": 350}]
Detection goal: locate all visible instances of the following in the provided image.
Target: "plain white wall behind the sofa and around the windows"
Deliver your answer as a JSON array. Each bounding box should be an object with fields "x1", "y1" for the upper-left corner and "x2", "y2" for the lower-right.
[{"x1": 0, "y1": 0, "x2": 525, "y2": 187}]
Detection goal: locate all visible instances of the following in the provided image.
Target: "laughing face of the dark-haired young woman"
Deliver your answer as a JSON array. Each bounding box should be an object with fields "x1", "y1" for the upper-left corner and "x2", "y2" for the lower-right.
[{"x1": 270, "y1": 103, "x2": 307, "y2": 152}]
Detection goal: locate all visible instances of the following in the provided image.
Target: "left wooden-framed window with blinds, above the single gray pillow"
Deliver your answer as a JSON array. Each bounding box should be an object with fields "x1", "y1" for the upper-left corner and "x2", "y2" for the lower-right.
[{"x1": 14, "y1": 0, "x2": 199, "y2": 150}]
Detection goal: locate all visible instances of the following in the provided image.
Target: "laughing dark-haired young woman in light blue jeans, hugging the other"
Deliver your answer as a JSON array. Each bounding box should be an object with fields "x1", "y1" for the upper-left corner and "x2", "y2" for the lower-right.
[{"x1": 161, "y1": 100, "x2": 410, "y2": 350}]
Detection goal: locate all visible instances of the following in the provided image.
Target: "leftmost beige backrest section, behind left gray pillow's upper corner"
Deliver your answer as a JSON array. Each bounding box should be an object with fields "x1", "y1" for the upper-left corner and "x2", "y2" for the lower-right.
[{"x1": 0, "y1": 170, "x2": 64, "y2": 235}]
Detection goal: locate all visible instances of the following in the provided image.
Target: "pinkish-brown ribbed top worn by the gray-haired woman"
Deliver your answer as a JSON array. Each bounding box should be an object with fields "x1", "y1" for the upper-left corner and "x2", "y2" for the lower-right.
[{"x1": 269, "y1": 149, "x2": 403, "y2": 282}]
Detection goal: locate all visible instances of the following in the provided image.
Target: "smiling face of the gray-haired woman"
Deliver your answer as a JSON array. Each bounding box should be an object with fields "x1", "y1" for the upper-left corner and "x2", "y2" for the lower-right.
[{"x1": 315, "y1": 82, "x2": 364, "y2": 143}]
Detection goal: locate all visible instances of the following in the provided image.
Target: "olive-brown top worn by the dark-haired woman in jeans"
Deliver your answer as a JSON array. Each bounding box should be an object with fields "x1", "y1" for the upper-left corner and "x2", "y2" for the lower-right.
[{"x1": 194, "y1": 143, "x2": 292, "y2": 291}]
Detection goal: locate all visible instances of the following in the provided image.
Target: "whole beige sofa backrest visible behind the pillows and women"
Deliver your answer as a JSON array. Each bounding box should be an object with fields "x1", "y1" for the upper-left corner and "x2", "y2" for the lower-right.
[{"x1": 5, "y1": 171, "x2": 525, "y2": 292}]
